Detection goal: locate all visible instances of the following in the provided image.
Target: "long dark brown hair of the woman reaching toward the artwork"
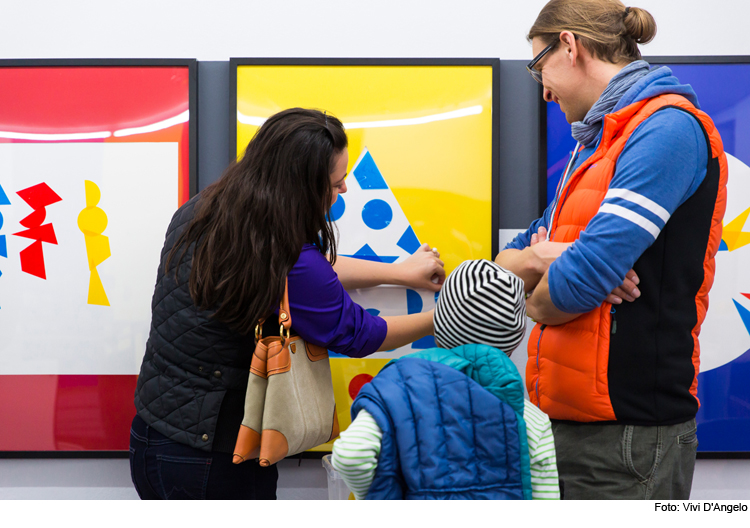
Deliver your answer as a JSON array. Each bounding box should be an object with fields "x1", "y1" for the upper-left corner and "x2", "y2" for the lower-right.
[{"x1": 166, "y1": 108, "x2": 347, "y2": 334}]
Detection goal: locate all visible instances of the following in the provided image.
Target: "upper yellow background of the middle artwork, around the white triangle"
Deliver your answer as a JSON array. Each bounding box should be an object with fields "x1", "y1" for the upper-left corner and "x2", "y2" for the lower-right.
[{"x1": 237, "y1": 65, "x2": 493, "y2": 271}]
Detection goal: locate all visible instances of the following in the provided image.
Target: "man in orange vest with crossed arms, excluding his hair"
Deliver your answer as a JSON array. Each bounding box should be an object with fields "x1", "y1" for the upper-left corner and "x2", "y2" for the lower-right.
[{"x1": 496, "y1": 7, "x2": 727, "y2": 499}]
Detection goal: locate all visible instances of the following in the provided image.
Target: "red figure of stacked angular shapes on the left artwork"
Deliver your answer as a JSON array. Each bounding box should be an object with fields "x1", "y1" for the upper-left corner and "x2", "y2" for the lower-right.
[{"x1": 14, "y1": 183, "x2": 62, "y2": 279}]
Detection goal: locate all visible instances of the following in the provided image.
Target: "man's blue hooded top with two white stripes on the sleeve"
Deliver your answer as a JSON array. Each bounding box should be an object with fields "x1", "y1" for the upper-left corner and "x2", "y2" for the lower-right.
[{"x1": 506, "y1": 68, "x2": 708, "y2": 313}]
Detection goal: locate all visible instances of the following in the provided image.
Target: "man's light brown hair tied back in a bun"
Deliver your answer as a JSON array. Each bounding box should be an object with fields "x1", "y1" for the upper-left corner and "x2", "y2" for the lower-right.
[{"x1": 527, "y1": 0, "x2": 656, "y2": 64}]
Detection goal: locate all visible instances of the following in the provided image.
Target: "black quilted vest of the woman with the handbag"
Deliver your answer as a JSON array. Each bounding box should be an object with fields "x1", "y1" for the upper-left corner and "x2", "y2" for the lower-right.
[{"x1": 135, "y1": 195, "x2": 255, "y2": 451}]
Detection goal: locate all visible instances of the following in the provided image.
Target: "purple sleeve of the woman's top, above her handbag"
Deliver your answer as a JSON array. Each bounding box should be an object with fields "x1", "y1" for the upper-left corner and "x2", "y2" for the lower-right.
[{"x1": 275, "y1": 244, "x2": 388, "y2": 358}]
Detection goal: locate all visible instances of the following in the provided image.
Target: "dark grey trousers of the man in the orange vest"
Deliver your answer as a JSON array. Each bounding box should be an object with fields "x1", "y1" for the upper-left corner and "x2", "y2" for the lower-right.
[{"x1": 552, "y1": 420, "x2": 698, "y2": 500}]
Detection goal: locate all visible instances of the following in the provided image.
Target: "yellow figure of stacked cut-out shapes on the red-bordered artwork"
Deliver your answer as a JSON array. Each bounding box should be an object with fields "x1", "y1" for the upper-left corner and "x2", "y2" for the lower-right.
[{"x1": 78, "y1": 180, "x2": 112, "y2": 306}]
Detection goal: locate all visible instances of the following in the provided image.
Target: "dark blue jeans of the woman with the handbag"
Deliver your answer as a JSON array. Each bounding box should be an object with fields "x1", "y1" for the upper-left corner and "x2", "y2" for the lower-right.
[{"x1": 130, "y1": 415, "x2": 279, "y2": 500}]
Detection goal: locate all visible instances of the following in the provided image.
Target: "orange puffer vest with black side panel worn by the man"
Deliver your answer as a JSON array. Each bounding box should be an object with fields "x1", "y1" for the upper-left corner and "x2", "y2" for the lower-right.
[{"x1": 526, "y1": 94, "x2": 727, "y2": 425}]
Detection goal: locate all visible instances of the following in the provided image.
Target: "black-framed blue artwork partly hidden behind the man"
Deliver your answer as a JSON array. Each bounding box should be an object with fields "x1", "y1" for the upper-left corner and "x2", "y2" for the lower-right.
[{"x1": 540, "y1": 56, "x2": 750, "y2": 458}]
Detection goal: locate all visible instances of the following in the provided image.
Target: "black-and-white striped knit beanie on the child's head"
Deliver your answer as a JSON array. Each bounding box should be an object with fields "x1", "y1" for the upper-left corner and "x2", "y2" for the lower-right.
[{"x1": 435, "y1": 260, "x2": 526, "y2": 356}]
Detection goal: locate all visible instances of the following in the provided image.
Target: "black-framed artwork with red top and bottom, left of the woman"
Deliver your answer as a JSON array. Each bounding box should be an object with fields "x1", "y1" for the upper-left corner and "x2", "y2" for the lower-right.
[{"x1": 0, "y1": 60, "x2": 197, "y2": 455}]
